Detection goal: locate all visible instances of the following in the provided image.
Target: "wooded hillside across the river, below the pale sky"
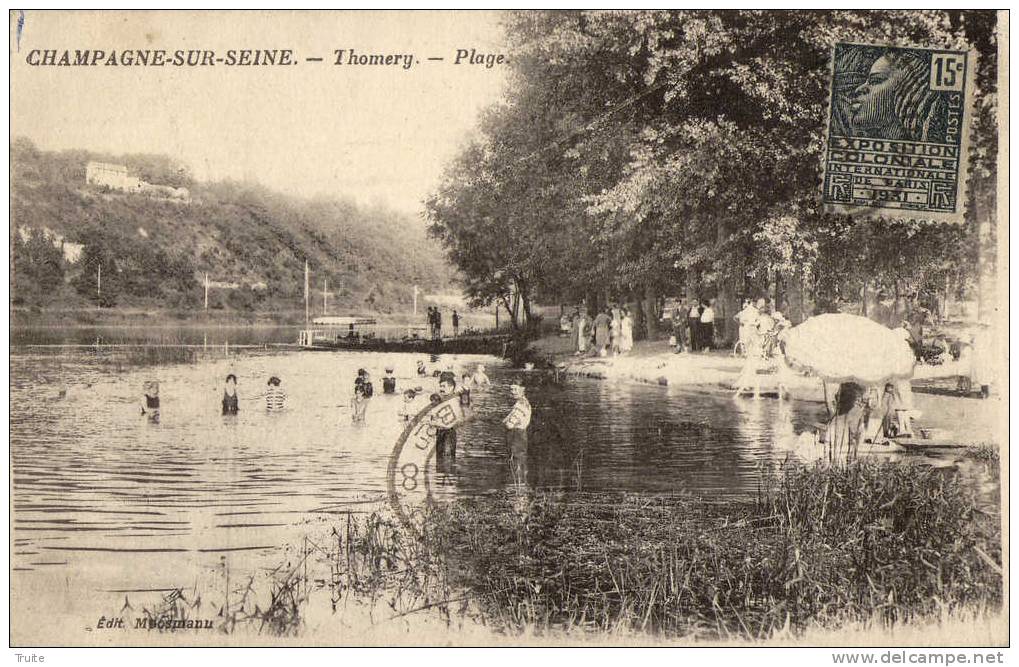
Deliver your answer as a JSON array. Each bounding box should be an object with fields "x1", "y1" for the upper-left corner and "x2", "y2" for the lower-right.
[{"x1": 10, "y1": 140, "x2": 453, "y2": 312}]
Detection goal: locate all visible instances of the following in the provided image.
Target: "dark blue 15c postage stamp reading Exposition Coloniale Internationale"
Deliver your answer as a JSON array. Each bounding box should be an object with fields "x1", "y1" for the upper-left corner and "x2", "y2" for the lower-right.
[{"x1": 823, "y1": 44, "x2": 974, "y2": 222}]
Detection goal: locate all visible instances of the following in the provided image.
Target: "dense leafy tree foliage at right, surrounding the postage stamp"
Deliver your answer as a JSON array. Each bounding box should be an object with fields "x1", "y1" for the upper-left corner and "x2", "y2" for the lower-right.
[{"x1": 428, "y1": 10, "x2": 997, "y2": 340}]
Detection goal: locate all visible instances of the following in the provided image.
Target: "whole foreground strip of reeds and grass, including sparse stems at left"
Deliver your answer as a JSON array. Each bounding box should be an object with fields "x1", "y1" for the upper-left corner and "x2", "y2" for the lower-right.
[{"x1": 163, "y1": 460, "x2": 1004, "y2": 644}]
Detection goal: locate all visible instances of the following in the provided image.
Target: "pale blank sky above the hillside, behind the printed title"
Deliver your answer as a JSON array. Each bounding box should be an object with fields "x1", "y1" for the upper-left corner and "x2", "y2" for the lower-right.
[{"x1": 9, "y1": 11, "x2": 506, "y2": 213}]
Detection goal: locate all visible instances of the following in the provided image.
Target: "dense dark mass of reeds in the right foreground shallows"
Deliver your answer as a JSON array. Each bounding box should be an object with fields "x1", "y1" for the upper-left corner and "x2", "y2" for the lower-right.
[{"x1": 421, "y1": 461, "x2": 1002, "y2": 638}]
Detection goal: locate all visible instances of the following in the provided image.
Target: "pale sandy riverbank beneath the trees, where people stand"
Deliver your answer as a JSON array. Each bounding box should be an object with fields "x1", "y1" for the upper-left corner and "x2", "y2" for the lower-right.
[{"x1": 530, "y1": 336, "x2": 1007, "y2": 446}]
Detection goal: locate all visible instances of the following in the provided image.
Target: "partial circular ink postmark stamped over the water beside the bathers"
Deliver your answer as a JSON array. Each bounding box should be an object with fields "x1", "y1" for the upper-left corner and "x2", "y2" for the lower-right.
[{"x1": 386, "y1": 394, "x2": 466, "y2": 537}]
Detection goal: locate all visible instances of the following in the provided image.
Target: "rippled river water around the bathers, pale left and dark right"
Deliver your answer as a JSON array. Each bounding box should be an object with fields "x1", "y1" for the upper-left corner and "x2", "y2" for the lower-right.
[{"x1": 10, "y1": 325, "x2": 994, "y2": 633}]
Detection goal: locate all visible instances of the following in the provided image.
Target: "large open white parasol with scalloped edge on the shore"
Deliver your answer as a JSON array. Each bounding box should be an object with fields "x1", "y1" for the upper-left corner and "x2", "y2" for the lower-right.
[{"x1": 782, "y1": 313, "x2": 915, "y2": 386}]
